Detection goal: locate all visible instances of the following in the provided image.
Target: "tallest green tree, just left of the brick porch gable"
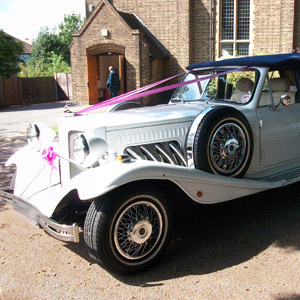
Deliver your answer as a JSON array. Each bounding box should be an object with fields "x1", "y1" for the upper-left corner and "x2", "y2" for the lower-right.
[{"x1": 58, "y1": 13, "x2": 85, "y2": 64}]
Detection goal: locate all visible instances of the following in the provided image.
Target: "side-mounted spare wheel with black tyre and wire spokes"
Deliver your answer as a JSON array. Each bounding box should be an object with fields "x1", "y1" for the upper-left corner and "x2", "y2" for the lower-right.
[{"x1": 193, "y1": 107, "x2": 253, "y2": 178}]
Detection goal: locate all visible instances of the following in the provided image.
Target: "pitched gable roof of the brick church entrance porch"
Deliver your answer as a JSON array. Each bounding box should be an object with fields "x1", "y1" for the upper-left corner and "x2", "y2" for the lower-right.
[{"x1": 73, "y1": 0, "x2": 170, "y2": 58}]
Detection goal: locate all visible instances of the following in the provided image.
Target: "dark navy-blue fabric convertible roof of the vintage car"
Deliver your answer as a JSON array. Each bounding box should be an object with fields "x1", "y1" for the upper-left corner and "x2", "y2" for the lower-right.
[{"x1": 187, "y1": 53, "x2": 300, "y2": 70}]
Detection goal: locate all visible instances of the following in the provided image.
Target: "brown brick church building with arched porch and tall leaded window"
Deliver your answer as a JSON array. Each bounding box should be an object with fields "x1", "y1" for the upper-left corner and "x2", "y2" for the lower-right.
[{"x1": 71, "y1": 0, "x2": 300, "y2": 104}]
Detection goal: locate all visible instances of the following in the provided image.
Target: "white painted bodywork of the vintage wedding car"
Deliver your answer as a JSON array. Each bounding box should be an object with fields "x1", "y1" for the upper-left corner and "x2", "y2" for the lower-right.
[{"x1": 3, "y1": 54, "x2": 300, "y2": 246}]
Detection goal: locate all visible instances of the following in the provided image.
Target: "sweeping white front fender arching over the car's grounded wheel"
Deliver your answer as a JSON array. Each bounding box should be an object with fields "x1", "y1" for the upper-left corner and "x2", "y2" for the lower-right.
[{"x1": 70, "y1": 161, "x2": 284, "y2": 204}]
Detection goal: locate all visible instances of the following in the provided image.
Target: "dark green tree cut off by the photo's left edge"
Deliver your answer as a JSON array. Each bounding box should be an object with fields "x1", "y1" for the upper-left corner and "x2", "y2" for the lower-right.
[{"x1": 0, "y1": 30, "x2": 23, "y2": 78}]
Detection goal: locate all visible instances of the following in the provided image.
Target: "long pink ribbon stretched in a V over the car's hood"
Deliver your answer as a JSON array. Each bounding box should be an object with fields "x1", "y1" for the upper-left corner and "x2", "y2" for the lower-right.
[{"x1": 74, "y1": 67, "x2": 250, "y2": 116}]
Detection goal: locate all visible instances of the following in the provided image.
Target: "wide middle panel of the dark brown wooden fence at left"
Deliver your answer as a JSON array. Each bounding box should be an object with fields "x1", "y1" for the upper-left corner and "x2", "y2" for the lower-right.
[{"x1": 21, "y1": 77, "x2": 57, "y2": 104}]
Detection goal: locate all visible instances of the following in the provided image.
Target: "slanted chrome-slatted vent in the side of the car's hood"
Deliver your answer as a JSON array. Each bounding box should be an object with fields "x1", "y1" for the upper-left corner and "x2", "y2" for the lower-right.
[{"x1": 125, "y1": 142, "x2": 187, "y2": 166}]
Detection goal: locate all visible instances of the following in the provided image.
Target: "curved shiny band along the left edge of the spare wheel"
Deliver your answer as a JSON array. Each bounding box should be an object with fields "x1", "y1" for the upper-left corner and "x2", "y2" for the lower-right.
[{"x1": 185, "y1": 106, "x2": 215, "y2": 168}]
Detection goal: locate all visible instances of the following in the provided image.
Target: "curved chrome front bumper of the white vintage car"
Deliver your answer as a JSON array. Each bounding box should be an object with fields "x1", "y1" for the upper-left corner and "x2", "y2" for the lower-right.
[{"x1": 0, "y1": 190, "x2": 79, "y2": 243}]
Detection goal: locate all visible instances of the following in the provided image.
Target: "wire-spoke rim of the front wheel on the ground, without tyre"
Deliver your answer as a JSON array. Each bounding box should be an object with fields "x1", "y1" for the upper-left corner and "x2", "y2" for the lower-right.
[{"x1": 113, "y1": 200, "x2": 163, "y2": 260}]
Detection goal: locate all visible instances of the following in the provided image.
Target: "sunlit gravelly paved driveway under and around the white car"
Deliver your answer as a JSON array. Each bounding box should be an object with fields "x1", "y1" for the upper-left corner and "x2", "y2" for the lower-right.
[{"x1": 0, "y1": 102, "x2": 300, "y2": 300}]
